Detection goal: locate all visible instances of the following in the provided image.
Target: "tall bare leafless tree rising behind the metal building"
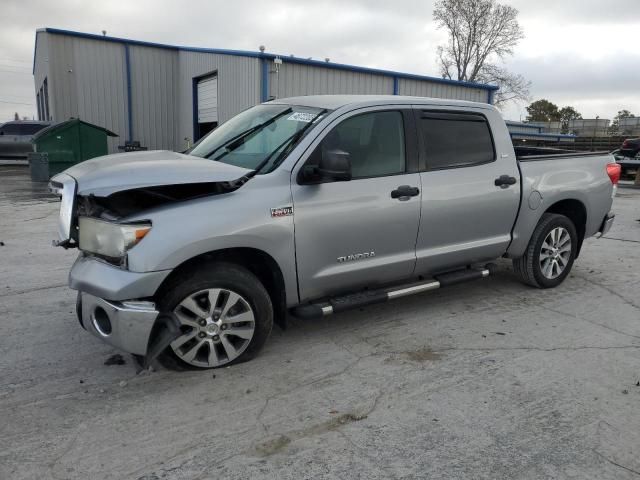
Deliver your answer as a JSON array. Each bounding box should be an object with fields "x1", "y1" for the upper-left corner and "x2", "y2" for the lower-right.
[{"x1": 433, "y1": 0, "x2": 531, "y2": 106}]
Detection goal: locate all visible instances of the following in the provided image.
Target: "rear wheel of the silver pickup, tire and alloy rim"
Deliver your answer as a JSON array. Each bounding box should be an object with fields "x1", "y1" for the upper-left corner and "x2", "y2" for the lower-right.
[{"x1": 513, "y1": 213, "x2": 578, "y2": 288}]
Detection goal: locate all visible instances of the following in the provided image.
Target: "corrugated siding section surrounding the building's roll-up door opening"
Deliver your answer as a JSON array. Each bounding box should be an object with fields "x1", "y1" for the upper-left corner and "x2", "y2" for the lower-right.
[{"x1": 175, "y1": 51, "x2": 260, "y2": 150}]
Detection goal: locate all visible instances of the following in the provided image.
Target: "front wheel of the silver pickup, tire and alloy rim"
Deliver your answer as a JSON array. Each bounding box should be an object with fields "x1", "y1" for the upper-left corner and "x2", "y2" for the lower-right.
[{"x1": 157, "y1": 262, "x2": 273, "y2": 370}]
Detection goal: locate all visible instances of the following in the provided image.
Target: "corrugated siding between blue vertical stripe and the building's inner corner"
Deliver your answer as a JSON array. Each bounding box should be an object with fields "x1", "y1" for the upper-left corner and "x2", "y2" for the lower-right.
[{"x1": 128, "y1": 45, "x2": 178, "y2": 150}]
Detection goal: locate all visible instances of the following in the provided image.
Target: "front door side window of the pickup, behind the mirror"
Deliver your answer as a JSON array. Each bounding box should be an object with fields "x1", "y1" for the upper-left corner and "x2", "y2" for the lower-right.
[{"x1": 308, "y1": 111, "x2": 406, "y2": 179}]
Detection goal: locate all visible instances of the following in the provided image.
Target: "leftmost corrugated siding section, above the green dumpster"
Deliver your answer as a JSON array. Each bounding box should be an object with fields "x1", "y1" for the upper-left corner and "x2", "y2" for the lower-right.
[{"x1": 49, "y1": 34, "x2": 127, "y2": 152}]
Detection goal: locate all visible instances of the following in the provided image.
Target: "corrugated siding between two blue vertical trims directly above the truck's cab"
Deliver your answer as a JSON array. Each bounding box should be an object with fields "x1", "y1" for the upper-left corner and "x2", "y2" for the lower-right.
[{"x1": 269, "y1": 62, "x2": 393, "y2": 98}]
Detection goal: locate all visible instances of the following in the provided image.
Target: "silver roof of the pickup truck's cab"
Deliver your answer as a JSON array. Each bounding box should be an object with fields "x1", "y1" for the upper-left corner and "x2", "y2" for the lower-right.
[{"x1": 268, "y1": 95, "x2": 495, "y2": 110}]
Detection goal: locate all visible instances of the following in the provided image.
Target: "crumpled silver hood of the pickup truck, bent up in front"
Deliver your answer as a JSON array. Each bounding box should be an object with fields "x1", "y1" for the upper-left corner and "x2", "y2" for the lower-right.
[{"x1": 64, "y1": 150, "x2": 250, "y2": 197}]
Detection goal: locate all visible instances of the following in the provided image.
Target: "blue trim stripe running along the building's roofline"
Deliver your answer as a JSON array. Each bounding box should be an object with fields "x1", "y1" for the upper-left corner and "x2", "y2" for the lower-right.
[{"x1": 34, "y1": 28, "x2": 499, "y2": 93}]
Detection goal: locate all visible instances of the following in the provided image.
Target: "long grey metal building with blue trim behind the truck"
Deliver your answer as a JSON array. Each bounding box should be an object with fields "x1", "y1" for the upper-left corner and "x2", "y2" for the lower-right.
[{"x1": 33, "y1": 28, "x2": 498, "y2": 152}]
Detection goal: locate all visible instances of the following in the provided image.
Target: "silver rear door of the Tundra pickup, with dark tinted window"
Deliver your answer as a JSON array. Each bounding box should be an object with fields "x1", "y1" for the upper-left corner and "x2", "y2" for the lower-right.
[{"x1": 414, "y1": 107, "x2": 520, "y2": 274}]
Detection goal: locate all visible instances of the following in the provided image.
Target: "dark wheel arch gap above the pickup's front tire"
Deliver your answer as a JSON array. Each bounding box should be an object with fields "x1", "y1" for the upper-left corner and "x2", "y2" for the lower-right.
[{"x1": 155, "y1": 247, "x2": 287, "y2": 328}]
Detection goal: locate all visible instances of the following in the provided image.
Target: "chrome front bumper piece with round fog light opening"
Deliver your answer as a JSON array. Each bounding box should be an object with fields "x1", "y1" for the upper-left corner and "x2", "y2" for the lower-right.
[{"x1": 79, "y1": 292, "x2": 158, "y2": 355}]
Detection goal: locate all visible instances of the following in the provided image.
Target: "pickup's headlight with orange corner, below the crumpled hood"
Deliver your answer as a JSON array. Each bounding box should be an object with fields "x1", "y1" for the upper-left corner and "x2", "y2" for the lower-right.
[{"x1": 78, "y1": 217, "x2": 151, "y2": 258}]
